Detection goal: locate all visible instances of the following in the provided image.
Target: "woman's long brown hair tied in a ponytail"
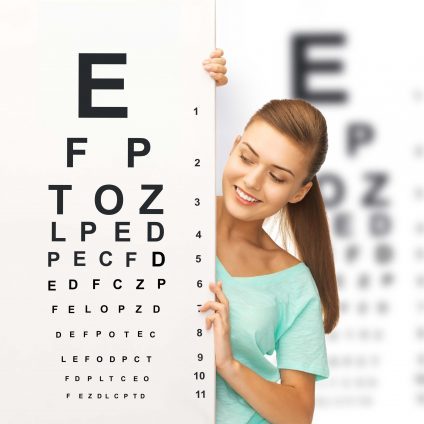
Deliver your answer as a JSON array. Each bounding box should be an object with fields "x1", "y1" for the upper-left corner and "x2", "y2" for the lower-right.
[{"x1": 245, "y1": 99, "x2": 339, "y2": 333}]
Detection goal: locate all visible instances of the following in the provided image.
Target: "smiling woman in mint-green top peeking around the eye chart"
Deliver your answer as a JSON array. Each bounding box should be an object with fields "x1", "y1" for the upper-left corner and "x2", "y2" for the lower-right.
[{"x1": 200, "y1": 49, "x2": 339, "y2": 424}]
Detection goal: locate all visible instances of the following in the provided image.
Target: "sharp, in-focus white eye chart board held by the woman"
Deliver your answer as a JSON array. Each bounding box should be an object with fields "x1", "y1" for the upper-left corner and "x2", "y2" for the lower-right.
[{"x1": 0, "y1": 0, "x2": 215, "y2": 424}]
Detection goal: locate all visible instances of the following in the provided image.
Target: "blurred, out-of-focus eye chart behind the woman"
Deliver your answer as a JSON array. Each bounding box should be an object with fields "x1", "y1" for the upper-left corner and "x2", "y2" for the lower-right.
[{"x1": 217, "y1": 0, "x2": 424, "y2": 424}]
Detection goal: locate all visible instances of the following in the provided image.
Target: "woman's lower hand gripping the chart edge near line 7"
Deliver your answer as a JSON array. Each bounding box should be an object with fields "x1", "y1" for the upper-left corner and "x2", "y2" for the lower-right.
[{"x1": 199, "y1": 281, "x2": 234, "y2": 372}]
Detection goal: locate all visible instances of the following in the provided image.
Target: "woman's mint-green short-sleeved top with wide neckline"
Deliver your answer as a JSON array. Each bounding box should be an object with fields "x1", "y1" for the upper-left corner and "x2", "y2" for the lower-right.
[{"x1": 215, "y1": 257, "x2": 330, "y2": 424}]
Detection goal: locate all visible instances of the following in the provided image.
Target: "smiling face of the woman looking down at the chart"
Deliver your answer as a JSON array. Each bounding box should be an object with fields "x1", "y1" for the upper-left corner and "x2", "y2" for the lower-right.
[{"x1": 222, "y1": 120, "x2": 312, "y2": 221}]
